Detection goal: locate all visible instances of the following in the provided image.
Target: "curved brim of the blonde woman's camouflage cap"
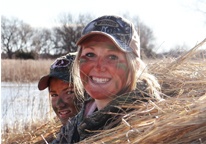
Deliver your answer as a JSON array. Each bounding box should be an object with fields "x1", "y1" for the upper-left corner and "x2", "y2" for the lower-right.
[{"x1": 76, "y1": 31, "x2": 133, "y2": 52}]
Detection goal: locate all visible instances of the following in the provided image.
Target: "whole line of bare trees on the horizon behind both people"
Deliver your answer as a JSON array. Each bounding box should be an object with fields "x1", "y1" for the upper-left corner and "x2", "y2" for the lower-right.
[{"x1": 1, "y1": 13, "x2": 158, "y2": 59}]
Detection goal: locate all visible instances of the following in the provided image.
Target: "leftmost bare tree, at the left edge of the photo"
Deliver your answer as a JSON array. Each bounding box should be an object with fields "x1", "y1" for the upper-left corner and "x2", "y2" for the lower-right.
[{"x1": 1, "y1": 16, "x2": 33, "y2": 59}]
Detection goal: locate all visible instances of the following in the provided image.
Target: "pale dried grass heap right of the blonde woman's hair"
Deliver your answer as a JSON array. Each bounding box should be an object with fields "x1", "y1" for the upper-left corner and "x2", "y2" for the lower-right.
[{"x1": 148, "y1": 39, "x2": 206, "y2": 97}]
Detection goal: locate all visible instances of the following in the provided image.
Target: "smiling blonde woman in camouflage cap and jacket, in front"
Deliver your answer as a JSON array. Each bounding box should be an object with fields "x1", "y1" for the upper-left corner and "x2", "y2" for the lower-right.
[{"x1": 54, "y1": 15, "x2": 161, "y2": 143}]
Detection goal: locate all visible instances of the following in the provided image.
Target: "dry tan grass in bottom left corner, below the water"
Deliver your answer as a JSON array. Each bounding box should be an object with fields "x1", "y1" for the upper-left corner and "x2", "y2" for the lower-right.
[{"x1": 1, "y1": 117, "x2": 61, "y2": 144}]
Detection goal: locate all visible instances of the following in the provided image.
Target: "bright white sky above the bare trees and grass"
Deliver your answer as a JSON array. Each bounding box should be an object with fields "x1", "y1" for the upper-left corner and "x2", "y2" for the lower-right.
[{"x1": 0, "y1": 0, "x2": 206, "y2": 53}]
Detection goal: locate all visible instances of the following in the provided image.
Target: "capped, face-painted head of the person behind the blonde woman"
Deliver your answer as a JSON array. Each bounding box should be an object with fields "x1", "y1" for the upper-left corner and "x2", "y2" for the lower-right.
[{"x1": 38, "y1": 54, "x2": 81, "y2": 125}]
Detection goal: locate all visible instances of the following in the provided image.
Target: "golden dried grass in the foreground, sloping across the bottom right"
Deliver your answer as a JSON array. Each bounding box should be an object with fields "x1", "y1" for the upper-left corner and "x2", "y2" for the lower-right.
[{"x1": 77, "y1": 95, "x2": 206, "y2": 144}]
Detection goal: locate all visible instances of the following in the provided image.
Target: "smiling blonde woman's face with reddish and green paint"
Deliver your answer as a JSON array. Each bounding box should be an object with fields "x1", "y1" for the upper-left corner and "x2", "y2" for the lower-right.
[{"x1": 79, "y1": 35, "x2": 128, "y2": 100}]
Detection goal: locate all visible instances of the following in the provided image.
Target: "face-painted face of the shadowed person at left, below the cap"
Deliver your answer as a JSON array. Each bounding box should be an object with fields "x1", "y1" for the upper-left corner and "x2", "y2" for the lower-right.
[{"x1": 49, "y1": 77, "x2": 77, "y2": 125}]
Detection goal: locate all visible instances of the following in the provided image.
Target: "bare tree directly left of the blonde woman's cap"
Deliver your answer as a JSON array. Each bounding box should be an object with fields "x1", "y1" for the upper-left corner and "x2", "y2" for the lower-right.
[{"x1": 53, "y1": 14, "x2": 92, "y2": 55}]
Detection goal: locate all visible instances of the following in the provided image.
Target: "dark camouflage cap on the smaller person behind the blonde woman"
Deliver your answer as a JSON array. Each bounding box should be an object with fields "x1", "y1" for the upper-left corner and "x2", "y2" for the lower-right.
[{"x1": 38, "y1": 53, "x2": 76, "y2": 90}]
